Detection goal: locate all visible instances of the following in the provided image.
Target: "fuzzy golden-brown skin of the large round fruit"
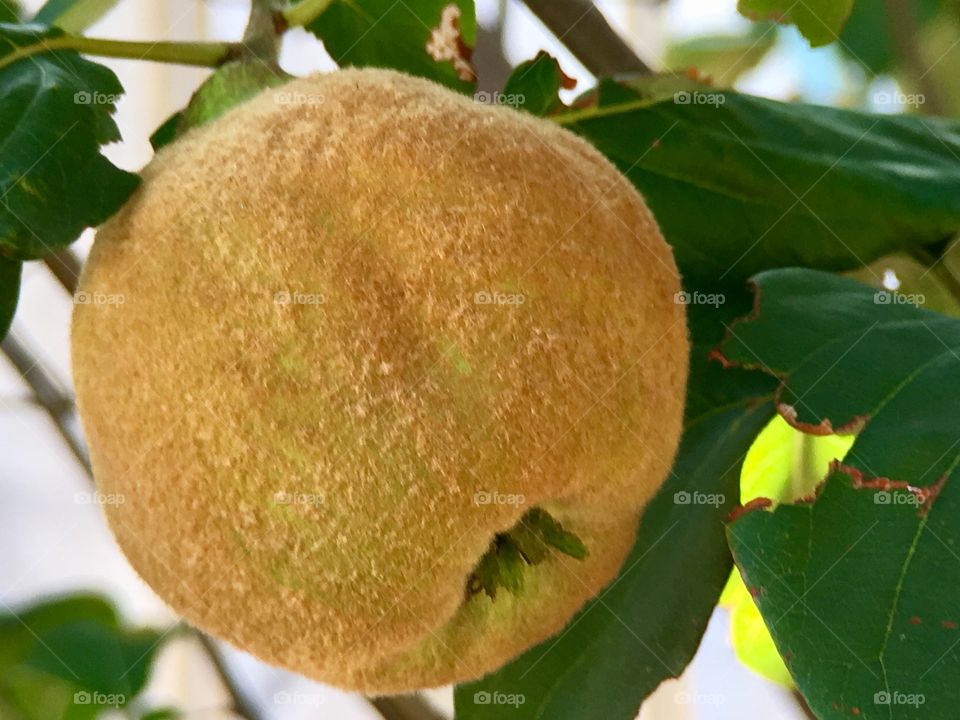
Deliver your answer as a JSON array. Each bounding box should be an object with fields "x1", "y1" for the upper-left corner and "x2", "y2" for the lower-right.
[{"x1": 72, "y1": 70, "x2": 688, "y2": 693}]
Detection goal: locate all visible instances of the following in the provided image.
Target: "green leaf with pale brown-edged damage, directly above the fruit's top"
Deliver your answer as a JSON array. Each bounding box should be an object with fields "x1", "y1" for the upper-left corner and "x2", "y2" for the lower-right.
[{"x1": 307, "y1": 0, "x2": 477, "y2": 92}]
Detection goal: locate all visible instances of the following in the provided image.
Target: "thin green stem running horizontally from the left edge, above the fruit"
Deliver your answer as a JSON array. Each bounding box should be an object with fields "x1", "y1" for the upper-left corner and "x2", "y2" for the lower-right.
[{"x1": 0, "y1": 34, "x2": 240, "y2": 69}]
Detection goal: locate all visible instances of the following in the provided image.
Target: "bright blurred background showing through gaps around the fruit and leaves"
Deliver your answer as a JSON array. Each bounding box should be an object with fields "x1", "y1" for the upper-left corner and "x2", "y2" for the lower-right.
[{"x1": 0, "y1": 0, "x2": 960, "y2": 720}]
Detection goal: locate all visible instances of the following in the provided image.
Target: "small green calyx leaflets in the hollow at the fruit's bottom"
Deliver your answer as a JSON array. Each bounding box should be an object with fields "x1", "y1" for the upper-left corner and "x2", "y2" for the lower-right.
[{"x1": 466, "y1": 508, "x2": 587, "y2": 600}]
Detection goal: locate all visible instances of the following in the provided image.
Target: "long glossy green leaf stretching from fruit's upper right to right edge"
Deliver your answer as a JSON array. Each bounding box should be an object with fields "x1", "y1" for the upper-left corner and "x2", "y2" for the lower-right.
[{"x1": 557, "y1": 78, "x2": 960, "y2": 281}]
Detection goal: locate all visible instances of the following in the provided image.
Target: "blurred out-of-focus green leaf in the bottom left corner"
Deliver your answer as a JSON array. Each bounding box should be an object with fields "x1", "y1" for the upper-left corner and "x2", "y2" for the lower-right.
[{"x1": 0, "y1": 595, "x2": 169, "y2": 720}]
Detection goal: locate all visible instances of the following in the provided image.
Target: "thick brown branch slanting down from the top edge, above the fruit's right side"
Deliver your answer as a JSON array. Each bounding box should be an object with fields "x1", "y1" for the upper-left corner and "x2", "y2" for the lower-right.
[{"x1": 523, "y1": 0, "x2": 653, "y2": 77}]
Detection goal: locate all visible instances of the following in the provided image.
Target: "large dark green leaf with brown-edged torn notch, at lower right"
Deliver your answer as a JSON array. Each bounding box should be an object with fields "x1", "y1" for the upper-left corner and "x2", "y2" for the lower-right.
[{"x1": 722, "y1": 270, "x2": 960, "y2": 718}]
